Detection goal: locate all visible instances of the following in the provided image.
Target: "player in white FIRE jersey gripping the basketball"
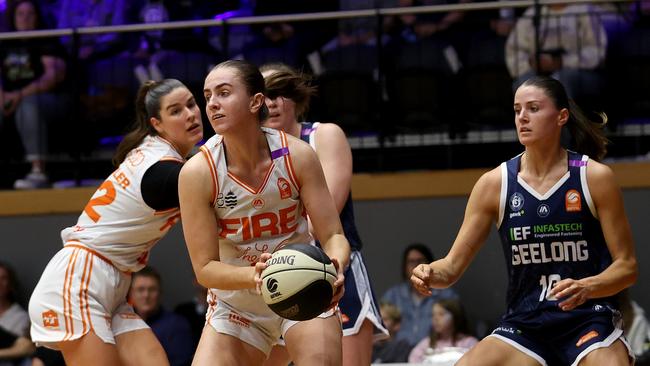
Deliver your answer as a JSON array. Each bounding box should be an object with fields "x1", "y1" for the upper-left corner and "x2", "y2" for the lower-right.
[{"x1": 179, "y1": 60, "x2": 350, "y2": 366}]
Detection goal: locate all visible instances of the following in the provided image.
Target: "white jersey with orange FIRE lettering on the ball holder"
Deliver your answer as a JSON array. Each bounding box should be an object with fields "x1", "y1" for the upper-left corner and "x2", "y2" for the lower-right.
[{"x1": 201, "y1": 128, "x2": 313, "y2": 315}]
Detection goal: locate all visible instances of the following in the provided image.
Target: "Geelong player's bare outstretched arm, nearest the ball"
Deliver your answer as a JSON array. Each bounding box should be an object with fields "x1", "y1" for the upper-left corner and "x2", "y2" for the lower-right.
[{"x1": 411, "y1": 168, "x2": 501, "y2": 295}]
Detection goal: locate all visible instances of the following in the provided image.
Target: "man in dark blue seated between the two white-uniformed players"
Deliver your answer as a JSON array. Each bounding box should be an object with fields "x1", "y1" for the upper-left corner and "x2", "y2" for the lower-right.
[{"x1": 129, "y1": 267, "x2": 194, "y2": 366}]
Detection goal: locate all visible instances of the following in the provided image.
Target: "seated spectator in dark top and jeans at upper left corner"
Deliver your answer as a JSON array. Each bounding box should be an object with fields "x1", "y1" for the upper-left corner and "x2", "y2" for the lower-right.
[{"x1": 0, "y1": 0, "x2": 68, "y2": 189}]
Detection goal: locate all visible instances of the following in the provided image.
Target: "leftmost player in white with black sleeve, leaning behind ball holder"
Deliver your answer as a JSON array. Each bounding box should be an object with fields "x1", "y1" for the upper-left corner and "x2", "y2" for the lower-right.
[{"x1": 29, "y1": 79, "x2": 203, "y2": 366}]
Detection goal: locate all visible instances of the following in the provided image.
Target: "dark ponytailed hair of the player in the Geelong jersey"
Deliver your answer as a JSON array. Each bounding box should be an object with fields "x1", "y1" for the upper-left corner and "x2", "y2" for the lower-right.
[{"x1": 522, "y1": 76, "x2": 609, "y2": 161}]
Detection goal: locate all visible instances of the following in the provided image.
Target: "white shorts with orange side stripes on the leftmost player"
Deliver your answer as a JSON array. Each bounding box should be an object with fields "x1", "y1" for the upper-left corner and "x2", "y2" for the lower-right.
[{"x1": 29, "y1": 244, "x2": 148, "y2": 349}]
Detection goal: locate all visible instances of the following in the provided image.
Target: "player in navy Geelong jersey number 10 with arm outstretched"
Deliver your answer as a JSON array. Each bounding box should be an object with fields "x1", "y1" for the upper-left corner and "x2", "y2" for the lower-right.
[{"x1": 411, "y1": 77, "x2": 637, "y2": 366}]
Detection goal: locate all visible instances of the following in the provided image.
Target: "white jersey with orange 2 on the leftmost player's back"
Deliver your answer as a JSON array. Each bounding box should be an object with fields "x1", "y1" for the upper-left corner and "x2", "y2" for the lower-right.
[{"x1": 61, "y1": 136, "x2": 185, "y2": 272}]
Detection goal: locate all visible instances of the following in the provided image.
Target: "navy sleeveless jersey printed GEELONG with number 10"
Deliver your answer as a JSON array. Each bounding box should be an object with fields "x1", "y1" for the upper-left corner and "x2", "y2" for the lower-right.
[{"x1": 497, "y1": 151, "x2": 615, "y2": 319}]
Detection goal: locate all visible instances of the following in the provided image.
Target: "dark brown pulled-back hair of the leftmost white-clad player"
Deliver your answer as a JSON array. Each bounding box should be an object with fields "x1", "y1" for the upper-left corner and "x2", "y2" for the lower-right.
[{"x1": 113, "y1": 79, "x2": 187, "y2": 167}]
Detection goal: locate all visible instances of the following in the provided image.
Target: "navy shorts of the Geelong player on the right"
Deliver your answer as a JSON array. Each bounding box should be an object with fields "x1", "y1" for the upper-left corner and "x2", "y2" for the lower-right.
[{"x1": 488, "y1": 304, "x2": 633, "y2": 366}]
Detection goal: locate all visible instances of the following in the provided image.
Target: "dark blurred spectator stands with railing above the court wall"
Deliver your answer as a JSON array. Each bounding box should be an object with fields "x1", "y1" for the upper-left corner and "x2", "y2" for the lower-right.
[{"x1": 0, "y1": 0, "x2": 650, "y2": 189}]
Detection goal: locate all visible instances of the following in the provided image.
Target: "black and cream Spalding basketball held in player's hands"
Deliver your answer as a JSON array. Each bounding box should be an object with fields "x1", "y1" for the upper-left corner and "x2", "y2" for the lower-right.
[{"x1": 262, "y1": 244, "x2": 336, "y2": 320}]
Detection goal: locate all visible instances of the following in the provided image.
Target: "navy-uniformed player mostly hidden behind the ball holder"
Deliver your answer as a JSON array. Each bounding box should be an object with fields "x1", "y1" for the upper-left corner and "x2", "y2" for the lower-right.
[{"x1": 260, "y1": 63, "x2": 388, "y2": 366}]
